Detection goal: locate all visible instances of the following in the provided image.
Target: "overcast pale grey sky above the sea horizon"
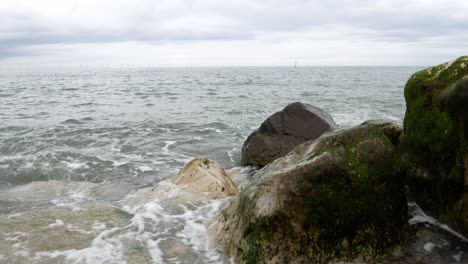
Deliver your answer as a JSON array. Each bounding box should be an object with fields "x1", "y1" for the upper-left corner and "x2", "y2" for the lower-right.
[{"x1": 0, "y1": 0, "x2": 468, "y2": 67}]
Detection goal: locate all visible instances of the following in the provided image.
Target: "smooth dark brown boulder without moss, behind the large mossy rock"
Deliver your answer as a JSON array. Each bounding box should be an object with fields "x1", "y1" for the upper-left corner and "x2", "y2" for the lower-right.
[{"x1": 242, "y1": 102, "x2": 336, "y2": 167}]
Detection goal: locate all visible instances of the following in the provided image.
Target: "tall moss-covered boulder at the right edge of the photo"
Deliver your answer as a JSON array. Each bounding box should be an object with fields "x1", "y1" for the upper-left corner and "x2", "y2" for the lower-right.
[{"x1": 399, "y1": 56, "x2": 468, "y2": 234}]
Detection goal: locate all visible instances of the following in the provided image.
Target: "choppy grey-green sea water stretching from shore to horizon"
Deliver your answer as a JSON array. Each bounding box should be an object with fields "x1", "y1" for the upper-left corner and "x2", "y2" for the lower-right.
[{"x1": 0, "y1": 67, "x2": 464, "y2": 263}]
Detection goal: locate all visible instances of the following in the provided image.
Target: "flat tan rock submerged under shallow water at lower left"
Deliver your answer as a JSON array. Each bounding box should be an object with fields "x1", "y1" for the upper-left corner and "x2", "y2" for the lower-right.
[{"x1": 0, "y1": 203, "x2": 130, "y2": 255}]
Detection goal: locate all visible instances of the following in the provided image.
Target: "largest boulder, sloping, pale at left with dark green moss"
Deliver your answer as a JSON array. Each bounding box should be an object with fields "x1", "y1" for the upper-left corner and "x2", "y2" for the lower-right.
[{"x1": 208, "y1": 121, "x2": 408, "y2": 263}]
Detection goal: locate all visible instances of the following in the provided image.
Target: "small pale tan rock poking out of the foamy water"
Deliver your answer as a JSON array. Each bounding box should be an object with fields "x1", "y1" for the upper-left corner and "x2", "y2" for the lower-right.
[{"x1": 175, "y1": 158, "x2": 237, "y2": 198}]
